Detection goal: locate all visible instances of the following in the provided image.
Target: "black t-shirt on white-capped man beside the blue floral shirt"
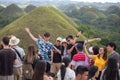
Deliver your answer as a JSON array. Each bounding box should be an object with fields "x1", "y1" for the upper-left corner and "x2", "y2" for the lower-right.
[{"x1": 53, "y1": 45, "x2": 62, "y2": 63}]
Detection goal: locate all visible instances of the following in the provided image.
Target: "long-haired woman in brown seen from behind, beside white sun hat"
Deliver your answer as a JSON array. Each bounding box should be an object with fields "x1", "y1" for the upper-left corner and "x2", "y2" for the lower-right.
[{"x1": 23, "y1": 45, "x2": 38, "y2": 80}]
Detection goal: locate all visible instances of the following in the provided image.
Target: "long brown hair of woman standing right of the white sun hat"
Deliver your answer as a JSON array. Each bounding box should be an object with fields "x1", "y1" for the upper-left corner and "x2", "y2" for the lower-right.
[{"x1": 26, "y1": 44, "x2": 35, "y2": 63}]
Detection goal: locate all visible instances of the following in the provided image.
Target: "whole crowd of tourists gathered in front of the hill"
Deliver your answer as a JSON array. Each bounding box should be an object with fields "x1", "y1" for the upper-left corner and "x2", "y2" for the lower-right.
[{"x1": 0, "y1": 28, "x2": 120, "y2": 80}]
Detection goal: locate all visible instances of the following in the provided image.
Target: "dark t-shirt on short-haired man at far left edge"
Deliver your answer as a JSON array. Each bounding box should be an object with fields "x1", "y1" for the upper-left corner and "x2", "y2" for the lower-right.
[{"x1": 0, "y1": 49, "x2": 16, "y2": 76}]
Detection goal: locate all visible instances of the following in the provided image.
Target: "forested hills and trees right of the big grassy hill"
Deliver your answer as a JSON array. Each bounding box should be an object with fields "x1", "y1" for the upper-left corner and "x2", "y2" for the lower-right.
[{"x1": 64, "y1": 5, "x2": 120, "y2": 53}]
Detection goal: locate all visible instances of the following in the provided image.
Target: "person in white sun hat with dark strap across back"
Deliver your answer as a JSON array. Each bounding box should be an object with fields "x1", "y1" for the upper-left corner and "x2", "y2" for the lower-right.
[{"x1": 9, "y1": 36, "x2": 25, "y2": 80}]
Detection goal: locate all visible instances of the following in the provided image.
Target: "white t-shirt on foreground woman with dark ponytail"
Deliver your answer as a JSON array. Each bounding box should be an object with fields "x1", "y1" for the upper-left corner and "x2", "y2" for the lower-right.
[{"x1": 57, "y1": 67, "x2": 75, "y2": 80}]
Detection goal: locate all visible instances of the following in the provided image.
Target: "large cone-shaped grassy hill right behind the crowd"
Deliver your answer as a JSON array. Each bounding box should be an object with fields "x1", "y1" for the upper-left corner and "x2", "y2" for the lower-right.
[{"x1": 0, "y1": 7, "x2": 83, "y2": 49}]
